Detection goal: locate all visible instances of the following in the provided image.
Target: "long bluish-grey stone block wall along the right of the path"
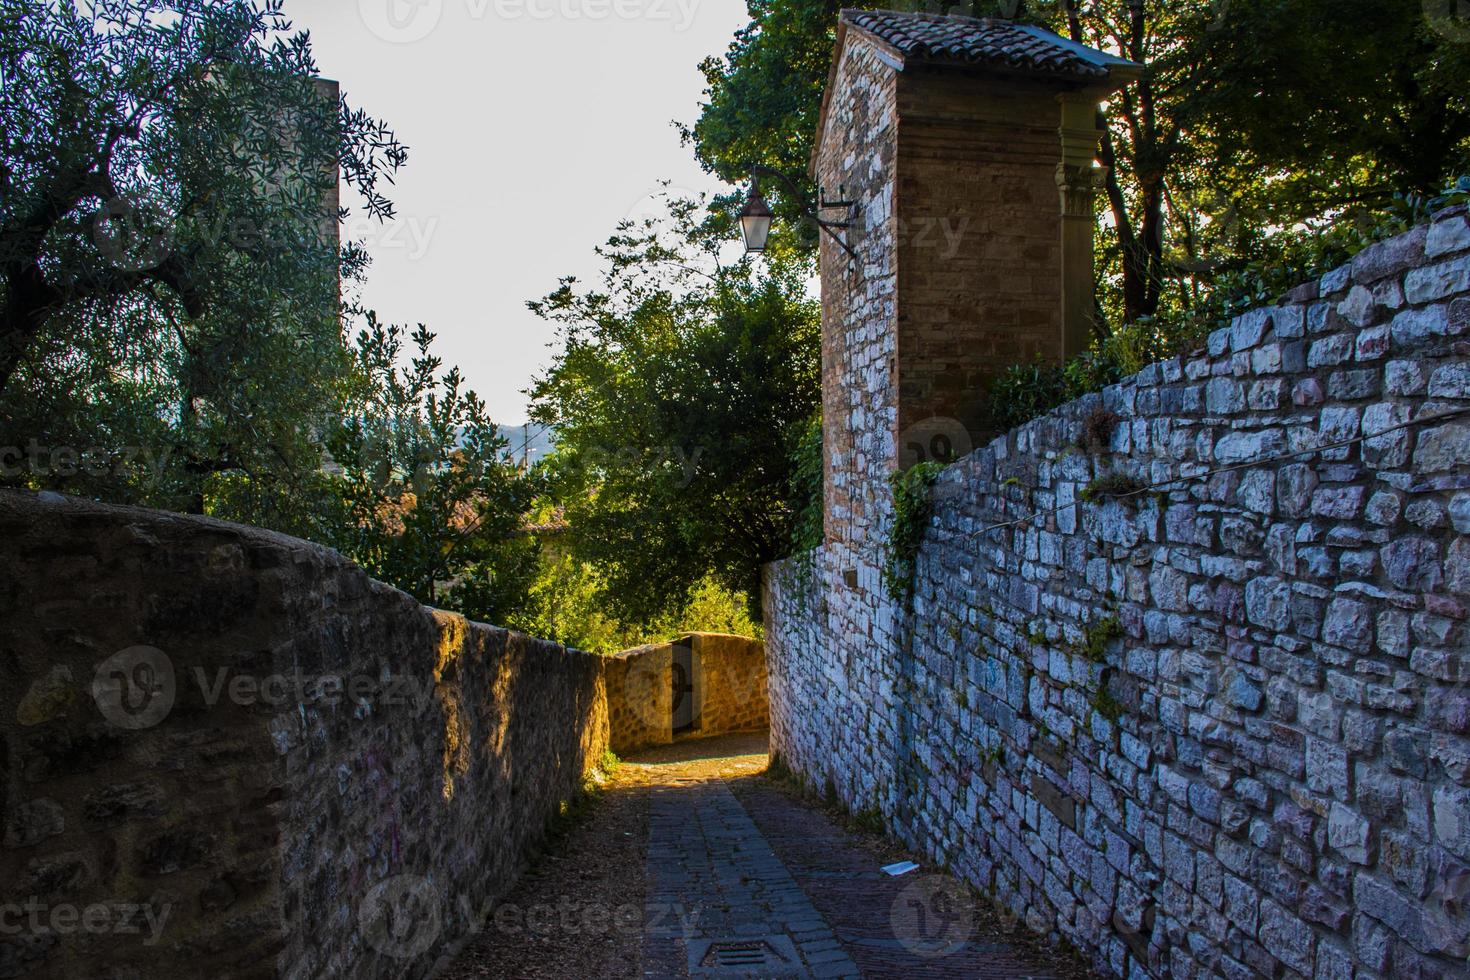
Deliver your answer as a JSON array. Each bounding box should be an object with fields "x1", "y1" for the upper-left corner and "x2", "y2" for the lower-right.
[{"x1": 766, "y1": 209, "x2": 1470, "y2": 980}]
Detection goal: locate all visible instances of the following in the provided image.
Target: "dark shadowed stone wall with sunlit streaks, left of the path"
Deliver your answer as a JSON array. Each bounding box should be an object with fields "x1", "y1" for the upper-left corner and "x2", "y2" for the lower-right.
[{"x1": 0, "y1": 491, "x2": 609, "y2": 979}]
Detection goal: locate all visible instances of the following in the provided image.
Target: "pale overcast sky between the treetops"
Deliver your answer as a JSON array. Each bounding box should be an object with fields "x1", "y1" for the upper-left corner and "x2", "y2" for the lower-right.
[{"x1": 285, "y1": 0, "x2": 748, "y2": 425}]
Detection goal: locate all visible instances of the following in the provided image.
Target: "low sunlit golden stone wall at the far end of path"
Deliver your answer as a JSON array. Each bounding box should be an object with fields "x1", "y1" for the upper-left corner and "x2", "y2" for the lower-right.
[{"x1": 607, "y1": 633, "x2": 769, "y2": 755}]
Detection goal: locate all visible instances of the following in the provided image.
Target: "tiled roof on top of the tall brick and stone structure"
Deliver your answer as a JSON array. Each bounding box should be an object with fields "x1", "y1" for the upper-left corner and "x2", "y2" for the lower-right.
[{"x1": 842, "y1": 10, "x2": 1133, "y2": 78}]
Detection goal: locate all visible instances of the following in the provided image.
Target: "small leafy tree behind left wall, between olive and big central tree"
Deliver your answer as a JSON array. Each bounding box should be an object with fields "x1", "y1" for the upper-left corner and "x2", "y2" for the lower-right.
[{"x1": 313, "y1": 314, "x2": 538, "y2": 623}]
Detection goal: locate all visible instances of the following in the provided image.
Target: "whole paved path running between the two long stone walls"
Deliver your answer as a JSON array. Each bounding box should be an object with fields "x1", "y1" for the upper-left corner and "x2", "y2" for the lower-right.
[{"x1": 444, "y1": 736, "x2": 1091, "y2": 980}]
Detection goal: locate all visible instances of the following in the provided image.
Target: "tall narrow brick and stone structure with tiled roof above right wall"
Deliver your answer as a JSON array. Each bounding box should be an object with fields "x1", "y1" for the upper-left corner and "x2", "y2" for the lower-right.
[{"x1": 813, "y1": 10, "x2": 1142, "y2": 547}]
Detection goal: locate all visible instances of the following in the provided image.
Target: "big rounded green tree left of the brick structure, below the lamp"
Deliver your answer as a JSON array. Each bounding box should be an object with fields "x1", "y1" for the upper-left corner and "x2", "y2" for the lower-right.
[{"x1": 529, "y1": 198, "x2": 820, "y2": 624}]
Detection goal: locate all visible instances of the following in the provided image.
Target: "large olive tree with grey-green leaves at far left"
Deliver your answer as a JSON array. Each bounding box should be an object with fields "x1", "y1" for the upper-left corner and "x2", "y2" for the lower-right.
[{"x1": 0, "y1": 0, "x2": 406, "y2": 517}]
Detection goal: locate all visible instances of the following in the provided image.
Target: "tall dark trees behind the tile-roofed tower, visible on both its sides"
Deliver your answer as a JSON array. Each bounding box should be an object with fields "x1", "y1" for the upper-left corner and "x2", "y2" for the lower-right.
[{"x1": 684, "y1": 0, "x2": 1470, "y2": 326}]
